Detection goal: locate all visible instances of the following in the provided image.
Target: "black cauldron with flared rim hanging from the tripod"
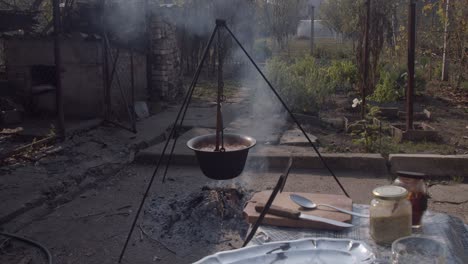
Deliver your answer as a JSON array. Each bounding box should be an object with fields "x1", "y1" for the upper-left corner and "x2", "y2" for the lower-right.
[{"x1": 187, "y1": 133, "x2": 257, "y2": 180}]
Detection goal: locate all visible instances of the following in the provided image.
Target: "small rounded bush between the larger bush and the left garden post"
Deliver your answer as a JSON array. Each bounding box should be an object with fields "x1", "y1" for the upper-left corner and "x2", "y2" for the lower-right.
[{"x1": 327, "y1": 60, "x2": 358, "y2": 90}]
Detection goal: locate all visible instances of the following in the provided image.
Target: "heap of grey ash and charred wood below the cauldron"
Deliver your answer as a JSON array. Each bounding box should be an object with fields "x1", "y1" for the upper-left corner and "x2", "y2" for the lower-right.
[{"x1": 143, "y1": 186, "x2": 252, "y2": 255}]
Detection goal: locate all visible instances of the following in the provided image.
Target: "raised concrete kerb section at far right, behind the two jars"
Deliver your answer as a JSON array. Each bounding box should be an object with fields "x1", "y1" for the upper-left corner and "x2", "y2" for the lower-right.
[{"x1": 389, "y1": 154, "x2": 468, "y2": 177}]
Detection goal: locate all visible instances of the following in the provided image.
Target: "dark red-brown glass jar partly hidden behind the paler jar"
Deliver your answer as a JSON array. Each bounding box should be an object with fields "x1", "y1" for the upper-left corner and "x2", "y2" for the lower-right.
[{"x1": 393, "y1": 171, "x2": 428, "y2": 228}]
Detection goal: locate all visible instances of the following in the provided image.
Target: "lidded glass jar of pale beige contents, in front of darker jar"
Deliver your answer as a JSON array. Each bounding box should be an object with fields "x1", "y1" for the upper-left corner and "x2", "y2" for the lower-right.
[{"x1": 369, "y1": 185, "x2": 411, "y2": 245}]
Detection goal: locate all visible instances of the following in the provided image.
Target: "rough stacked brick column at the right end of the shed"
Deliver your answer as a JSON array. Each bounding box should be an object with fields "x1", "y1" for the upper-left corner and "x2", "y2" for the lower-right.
[{"x1": 149, "y1": 16, "x2": 182, "y2": 101}]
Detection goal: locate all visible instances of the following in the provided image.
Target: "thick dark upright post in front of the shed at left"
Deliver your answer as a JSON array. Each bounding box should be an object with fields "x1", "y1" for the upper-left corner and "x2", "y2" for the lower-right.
[{"x1": 52, "y1": 0, "x2": 65, "y2": 140}]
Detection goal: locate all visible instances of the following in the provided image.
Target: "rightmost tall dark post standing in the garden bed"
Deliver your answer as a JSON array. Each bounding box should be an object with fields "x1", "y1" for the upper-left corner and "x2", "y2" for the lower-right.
[{"x1": 406, "y1": 0, "x2": 416, "y2": 131}]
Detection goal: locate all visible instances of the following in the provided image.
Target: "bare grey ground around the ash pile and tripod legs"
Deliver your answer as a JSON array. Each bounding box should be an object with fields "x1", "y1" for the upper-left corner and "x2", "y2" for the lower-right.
[{"x1": 0, "y1": 166, "x2": 387, "y2": 264}]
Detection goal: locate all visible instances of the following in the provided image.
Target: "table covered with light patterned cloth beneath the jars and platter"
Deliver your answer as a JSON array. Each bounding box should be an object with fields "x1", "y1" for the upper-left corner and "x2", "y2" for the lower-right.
[{"x1": 248, "y1": 204, "x2": 468, "y2": 264}]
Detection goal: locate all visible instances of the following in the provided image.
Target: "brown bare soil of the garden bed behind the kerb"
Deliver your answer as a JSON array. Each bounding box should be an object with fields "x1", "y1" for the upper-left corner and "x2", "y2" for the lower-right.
[{"x1": 314, "y1": 84, "x2": 468, "y2": 155}]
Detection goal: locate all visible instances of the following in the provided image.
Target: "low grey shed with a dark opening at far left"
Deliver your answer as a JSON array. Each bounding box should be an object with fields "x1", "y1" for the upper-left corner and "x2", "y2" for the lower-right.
[{"x1": 4, "y1": 34, "x2": 146, "y2": 118}]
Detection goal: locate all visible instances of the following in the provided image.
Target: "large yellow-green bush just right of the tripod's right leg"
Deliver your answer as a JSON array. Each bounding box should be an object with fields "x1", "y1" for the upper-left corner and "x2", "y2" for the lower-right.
[{"x1": 267, "y1": 56, "x2": 333, "y2": 114}]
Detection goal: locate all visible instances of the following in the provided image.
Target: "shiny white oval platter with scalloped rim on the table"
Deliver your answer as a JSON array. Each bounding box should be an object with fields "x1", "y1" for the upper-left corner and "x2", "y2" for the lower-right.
[{"x1": 195, "y1": 238, "x2": 375, "y2": 264}]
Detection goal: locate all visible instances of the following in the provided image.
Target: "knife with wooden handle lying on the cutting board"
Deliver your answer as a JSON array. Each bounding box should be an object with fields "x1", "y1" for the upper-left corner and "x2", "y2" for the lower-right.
[{"x1": 255, "y1": 203, "x2": 354, "y2": 227}]
